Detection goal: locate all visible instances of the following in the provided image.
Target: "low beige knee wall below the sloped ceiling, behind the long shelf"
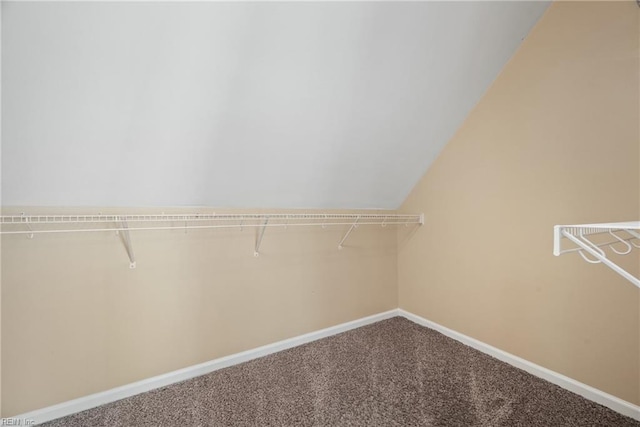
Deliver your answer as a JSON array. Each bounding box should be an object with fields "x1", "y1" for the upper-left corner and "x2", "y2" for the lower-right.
[{"x1": 2, "y1": 208, "x2": 398, "y2": 416}]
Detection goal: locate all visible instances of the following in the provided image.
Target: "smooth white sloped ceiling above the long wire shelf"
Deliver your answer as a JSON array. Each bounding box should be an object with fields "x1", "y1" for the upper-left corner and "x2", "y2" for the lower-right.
[{"x1": 2, "y1": 1, "x2": 548, "y2": 208}]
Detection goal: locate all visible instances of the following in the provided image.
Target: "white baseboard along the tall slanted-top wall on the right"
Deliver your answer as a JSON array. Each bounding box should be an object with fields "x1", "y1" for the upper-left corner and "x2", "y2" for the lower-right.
[{"x1": 398, "y1": 309, "x2": 640, "y2": 421}]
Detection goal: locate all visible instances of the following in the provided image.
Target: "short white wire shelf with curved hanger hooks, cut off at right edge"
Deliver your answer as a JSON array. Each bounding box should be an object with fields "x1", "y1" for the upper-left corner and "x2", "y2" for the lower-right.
[{"x1": 553, "y1": 221, "x2": 640, "y2": 288}]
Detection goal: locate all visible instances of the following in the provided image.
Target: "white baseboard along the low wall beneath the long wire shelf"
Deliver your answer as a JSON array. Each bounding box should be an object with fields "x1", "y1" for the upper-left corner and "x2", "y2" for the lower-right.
[{"x1": 16, "y1": 309, "x2": 398, "y2": 424}]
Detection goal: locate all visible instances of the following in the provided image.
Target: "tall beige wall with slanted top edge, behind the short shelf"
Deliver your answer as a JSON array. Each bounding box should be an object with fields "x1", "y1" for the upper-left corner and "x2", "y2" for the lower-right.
[{"x1": 398, "y1": 2, "x2": 640, "y2": 404}]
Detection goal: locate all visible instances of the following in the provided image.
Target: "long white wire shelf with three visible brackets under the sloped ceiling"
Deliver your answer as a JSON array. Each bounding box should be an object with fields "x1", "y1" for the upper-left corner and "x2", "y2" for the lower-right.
[{"x1": 0, "y1": 213, "x2": 424, "y2": 268}]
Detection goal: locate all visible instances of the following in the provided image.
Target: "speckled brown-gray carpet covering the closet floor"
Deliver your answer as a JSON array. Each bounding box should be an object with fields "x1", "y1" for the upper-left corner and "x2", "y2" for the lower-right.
[{"x1": 44, "y1": 317, "x2": 640, "y2": 427}]
